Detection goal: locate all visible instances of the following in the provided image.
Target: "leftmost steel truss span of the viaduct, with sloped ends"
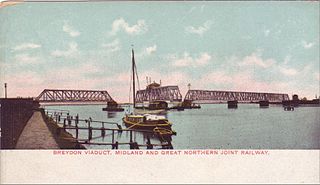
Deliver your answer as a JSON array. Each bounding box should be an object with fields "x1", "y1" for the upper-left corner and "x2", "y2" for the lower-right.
[{"x1": 36, "y1": 89, "x2": 114, "y2": 103}]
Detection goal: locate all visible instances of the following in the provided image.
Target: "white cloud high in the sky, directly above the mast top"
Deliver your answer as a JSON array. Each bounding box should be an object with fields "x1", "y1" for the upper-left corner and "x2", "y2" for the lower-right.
[{"x1": 109, "y1": 18, "x2": 148, "y2": 35}]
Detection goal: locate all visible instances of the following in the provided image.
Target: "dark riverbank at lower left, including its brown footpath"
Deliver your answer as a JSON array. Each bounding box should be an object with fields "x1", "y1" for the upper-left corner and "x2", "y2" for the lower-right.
[{"x1": 0, "y1": 98, "x2": 85, "y2": 149}]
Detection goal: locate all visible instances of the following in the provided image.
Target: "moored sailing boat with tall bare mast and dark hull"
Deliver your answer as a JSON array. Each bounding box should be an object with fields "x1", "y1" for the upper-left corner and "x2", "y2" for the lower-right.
[{"x1": 122, "y1": 49, "x2": 173, "y2": 133}]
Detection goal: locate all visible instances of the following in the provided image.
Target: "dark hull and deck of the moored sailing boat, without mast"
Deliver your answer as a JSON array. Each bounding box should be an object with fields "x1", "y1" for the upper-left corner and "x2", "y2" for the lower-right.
[{"x1": 122, "y1": 114, "x2": 172, "y2": 130}]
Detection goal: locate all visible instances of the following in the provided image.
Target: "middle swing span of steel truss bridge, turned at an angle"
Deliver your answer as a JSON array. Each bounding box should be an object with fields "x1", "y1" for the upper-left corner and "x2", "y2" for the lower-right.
[{"x1": 136, "y1": 86, "x2": 182, "y2": 103}]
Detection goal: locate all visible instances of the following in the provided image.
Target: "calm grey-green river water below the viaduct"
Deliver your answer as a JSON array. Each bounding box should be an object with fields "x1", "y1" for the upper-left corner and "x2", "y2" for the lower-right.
[{"x1": 46, "y1": 104, "x2": 320, "y2": 149}]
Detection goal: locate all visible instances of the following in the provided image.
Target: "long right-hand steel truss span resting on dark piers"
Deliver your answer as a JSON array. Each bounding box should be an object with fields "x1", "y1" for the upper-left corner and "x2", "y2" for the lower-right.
[{"x1": 184, "y1": 90, "x2": 289, "y2": 103}]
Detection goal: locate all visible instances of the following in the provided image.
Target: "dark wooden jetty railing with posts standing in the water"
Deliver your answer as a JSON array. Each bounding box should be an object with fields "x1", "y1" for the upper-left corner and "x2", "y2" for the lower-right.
[{"x1": 45, "y1": 109, "x2": 173, "y2": 149}]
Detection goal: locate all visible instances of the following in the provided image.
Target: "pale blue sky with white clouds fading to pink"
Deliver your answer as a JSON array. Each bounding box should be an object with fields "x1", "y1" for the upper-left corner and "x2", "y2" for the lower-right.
[{"x1": 0, "y1": 1, "x2": 320, "y2": 102}]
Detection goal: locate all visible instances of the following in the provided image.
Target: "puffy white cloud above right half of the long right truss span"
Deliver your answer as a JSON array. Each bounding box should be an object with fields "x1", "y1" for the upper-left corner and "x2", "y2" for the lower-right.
[{"x1": 239, "y1": 53, "x2": 275, "y2": 68}]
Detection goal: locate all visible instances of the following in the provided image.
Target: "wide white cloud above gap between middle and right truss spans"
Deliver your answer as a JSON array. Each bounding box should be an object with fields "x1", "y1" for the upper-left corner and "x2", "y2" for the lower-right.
[{"x1": 171, "y1": 52, "x2": 212, "y2": 67}]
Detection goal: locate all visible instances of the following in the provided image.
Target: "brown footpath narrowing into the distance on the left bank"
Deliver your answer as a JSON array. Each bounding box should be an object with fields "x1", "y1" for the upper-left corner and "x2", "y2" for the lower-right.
[{"x1": 16, "y1": 111, "x2": 59, "y2": 149}]
